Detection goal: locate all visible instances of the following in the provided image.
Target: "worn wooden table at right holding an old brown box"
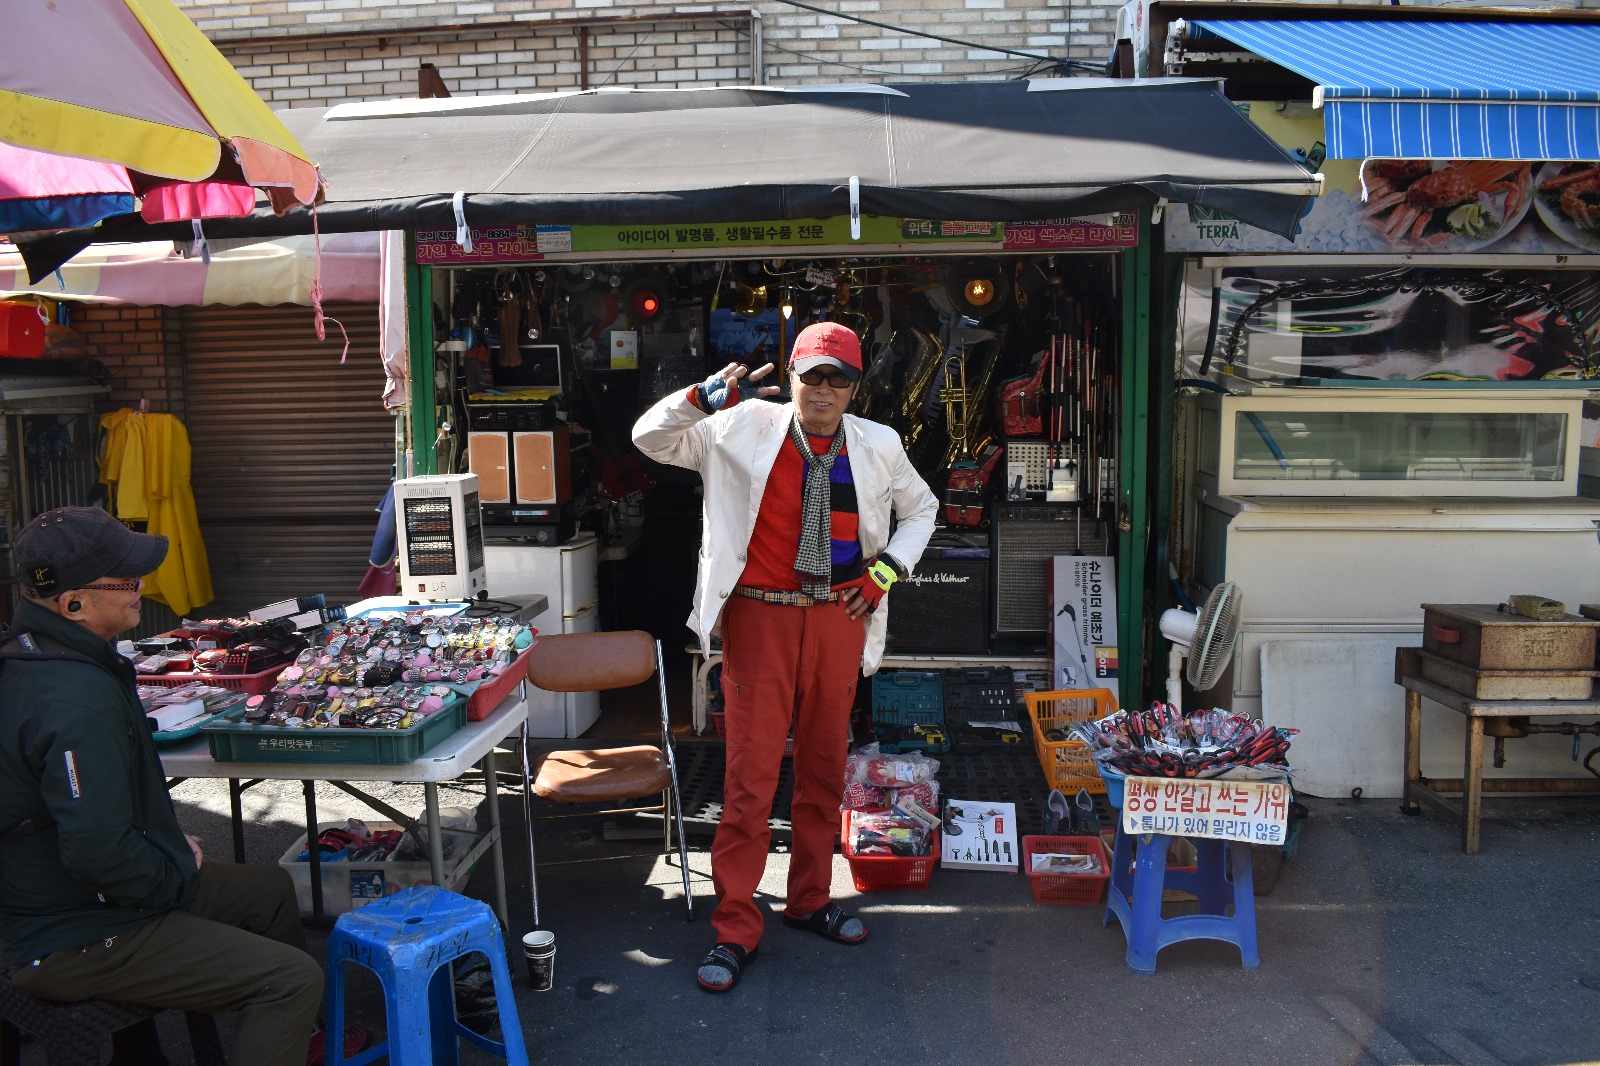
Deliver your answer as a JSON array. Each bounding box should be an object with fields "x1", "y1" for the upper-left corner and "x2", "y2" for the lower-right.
[{"x1": 1395, "y1": 648, "x2": 1600, "y2": 855}]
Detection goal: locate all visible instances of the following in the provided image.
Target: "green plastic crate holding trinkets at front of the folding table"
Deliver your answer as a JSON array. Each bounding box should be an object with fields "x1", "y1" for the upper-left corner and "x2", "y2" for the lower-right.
[{"x1": 202, "y1": 696, "x2": 467, "y2": 767}]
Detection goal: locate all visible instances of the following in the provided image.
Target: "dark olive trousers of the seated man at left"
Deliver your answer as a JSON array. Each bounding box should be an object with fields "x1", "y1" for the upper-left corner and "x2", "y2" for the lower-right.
[{"x1": 11, "y1": 861, "x2": 322, "y2": 1066}]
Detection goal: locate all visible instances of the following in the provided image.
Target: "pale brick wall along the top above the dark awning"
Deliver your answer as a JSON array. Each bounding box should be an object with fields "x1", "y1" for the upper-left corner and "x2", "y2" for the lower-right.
[{"x1": 178, "y1": 0, "x2": 1600, "y2": 107}]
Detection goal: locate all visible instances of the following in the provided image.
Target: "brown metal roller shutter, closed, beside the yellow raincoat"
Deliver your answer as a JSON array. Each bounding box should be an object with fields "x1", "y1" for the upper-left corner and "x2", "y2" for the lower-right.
[{"x1": 182, "y1": 304, "x2": 394, "y2": 613}]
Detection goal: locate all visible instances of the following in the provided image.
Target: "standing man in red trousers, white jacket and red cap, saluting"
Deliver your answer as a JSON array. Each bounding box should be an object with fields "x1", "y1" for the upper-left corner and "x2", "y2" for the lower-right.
[{"x1": 634, "y1": 322, "x2": 938, "y2": 992}]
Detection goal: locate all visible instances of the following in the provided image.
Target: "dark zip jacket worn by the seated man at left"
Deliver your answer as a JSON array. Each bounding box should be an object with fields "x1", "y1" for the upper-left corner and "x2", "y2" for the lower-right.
[{"x1": 0, "y1": 602, "x2": 195, "y2": 962}]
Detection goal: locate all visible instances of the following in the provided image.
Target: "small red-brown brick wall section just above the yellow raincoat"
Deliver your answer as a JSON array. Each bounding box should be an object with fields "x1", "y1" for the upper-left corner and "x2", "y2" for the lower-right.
[{"x1": 72, "y1": 304, "x2": 186, "y2": 418}]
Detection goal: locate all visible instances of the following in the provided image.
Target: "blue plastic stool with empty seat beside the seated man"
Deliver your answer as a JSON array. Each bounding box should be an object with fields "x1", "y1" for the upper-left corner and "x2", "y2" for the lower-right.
[{"x1": 326, "y1": 887, "x2": 528, "y2": 1066}]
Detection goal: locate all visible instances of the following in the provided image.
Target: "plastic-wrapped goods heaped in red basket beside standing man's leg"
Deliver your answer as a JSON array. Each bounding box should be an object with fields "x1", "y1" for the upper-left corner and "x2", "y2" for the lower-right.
[{"x1": 842, "y1": 744, "x2": 939, "y2": 856}]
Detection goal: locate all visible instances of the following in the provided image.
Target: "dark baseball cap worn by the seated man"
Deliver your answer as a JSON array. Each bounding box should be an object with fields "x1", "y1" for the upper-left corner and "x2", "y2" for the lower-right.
[{"x1": 11, "y1": 507, "x2": 166, "y2": 595}]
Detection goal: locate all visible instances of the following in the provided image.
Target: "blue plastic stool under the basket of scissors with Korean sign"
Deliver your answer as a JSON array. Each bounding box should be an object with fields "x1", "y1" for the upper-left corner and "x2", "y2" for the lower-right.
[{"x1": 1104, "y1": 826, "x2": 1261, "y2": 973}]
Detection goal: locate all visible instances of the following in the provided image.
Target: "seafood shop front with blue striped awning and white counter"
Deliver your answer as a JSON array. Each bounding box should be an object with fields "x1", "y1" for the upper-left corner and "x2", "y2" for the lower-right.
[{"x1": 1118, "y1": 0, "x2": 1600, "y2": 795}]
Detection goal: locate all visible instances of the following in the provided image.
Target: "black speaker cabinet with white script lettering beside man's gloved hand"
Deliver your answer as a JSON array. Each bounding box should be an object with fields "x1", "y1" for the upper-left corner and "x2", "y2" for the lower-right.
[{"x1": 886, "y1": 547, "x2": 990, "y2": 655}]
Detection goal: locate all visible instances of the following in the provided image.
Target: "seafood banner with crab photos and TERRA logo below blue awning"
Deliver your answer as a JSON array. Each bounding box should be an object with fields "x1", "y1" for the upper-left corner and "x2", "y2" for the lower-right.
[{"x1": 1166, "y1": 102, "x2": 1600, "y2": 254}]
